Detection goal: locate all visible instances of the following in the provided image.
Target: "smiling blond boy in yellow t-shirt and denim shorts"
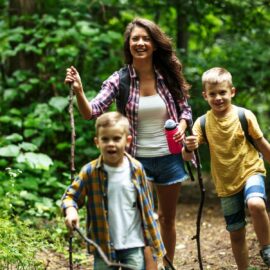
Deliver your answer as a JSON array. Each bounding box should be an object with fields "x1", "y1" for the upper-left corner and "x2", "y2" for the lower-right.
[{"x1": 185, "y1": 67, "x2": 270, "y2": 270}]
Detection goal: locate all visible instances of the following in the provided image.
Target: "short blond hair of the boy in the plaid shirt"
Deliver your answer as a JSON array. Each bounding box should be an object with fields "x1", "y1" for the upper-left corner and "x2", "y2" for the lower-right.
[{"x1": 95, "y1": 112, "x2": 129, "y2": 135}]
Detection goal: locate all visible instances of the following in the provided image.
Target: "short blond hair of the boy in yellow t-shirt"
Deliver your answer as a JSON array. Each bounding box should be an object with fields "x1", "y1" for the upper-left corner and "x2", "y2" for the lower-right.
[{"x1": 202, "y1": 67, "x2": 233, "y2": 91}]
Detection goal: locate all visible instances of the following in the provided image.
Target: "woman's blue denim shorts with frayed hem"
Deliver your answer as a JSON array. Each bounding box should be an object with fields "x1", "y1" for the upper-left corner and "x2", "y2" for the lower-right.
[{"x1": 136, "y1": 154, "x2": 189, "y2": 185}]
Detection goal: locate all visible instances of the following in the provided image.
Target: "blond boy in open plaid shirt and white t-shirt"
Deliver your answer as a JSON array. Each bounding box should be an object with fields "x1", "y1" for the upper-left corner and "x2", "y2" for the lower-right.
[{"x1": 62, "y1": 112, "x2": 165, "y2": 270}]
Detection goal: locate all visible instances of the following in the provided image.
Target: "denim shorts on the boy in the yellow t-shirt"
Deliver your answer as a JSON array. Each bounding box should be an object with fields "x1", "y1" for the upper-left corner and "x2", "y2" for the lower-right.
[{"x1": 221, "y1": 174, "x2": 266, "y2": 232}]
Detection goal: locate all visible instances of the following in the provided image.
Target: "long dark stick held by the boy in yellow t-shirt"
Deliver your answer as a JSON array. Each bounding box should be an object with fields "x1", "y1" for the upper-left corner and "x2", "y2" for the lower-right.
[{"x1": 188, "y1": 125, "x2": 205, "y2": 270}]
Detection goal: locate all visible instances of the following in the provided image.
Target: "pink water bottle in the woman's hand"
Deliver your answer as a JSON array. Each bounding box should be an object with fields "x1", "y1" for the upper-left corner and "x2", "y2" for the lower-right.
[{"x1": 164, "y1": 119, "x2": 182, "y2": 154}]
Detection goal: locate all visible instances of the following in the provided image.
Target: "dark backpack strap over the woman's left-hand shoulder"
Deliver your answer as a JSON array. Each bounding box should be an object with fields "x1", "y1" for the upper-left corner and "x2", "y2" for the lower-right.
[{"x1": 116, "y1": 67, "x2": 130, "y2": 115}]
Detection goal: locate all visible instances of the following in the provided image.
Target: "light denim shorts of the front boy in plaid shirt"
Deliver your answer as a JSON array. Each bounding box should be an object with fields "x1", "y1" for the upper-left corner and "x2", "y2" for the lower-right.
[{"x1": 94, "y1": 247, "x2": 145, "y2": 270}]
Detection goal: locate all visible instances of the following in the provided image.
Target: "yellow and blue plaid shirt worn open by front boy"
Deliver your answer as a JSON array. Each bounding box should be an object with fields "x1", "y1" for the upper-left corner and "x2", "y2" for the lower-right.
[{"x1": 62, "y1": 154, "x2": 165, "y2": 259}]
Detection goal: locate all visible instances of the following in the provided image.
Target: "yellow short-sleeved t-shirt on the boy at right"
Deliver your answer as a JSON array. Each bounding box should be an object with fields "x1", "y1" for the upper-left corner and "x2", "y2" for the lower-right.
[{"x1": 193, "y1": 106, "x2": 266, "y2": 197}]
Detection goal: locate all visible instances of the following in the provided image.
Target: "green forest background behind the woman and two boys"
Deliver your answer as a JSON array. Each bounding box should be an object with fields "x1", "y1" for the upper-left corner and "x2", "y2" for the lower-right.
[{"x1": 0, "y1": 0, "x2": 270, "y2": 269}]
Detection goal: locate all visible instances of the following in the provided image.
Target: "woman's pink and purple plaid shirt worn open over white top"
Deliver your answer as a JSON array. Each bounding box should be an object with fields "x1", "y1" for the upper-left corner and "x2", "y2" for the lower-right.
[{"x1": 89, "y1": 65, "x2": 192, "y2": 157}]
